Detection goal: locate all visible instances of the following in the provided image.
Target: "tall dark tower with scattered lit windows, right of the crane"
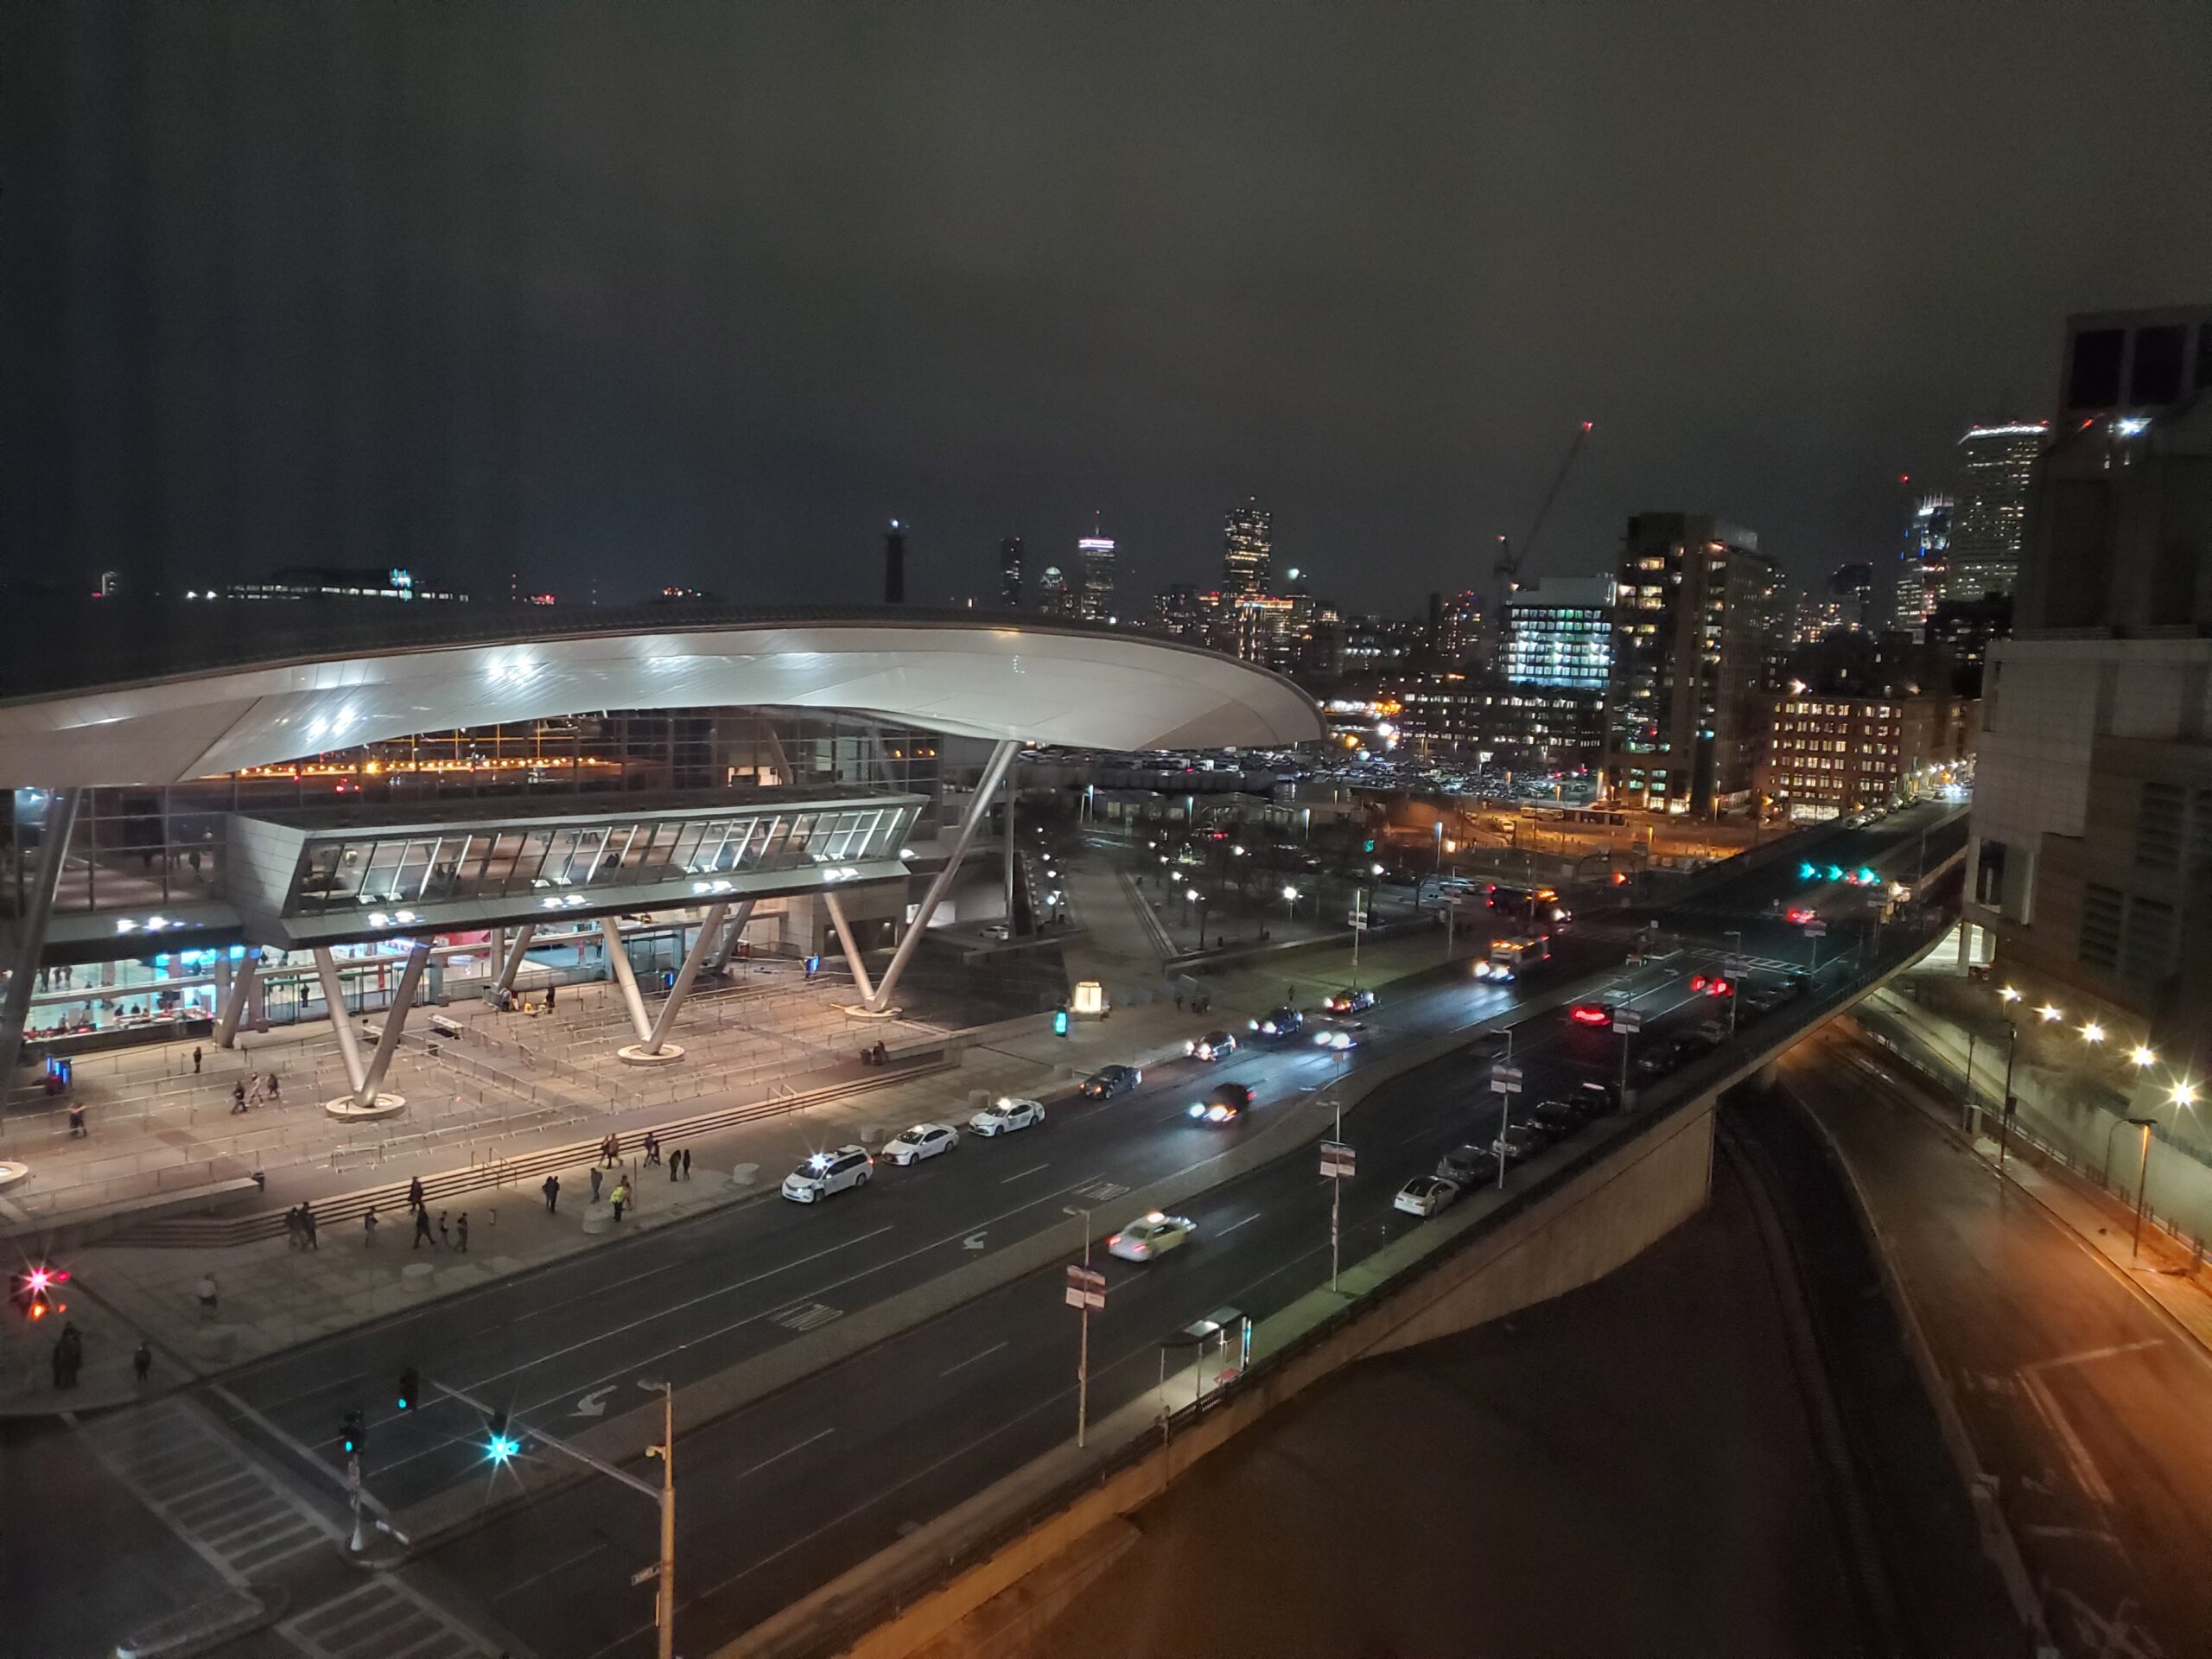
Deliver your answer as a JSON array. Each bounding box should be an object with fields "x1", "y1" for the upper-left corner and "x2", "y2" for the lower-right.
[{"x1": 1604, "y1": 513, "x2": 1781, "y2": 814}]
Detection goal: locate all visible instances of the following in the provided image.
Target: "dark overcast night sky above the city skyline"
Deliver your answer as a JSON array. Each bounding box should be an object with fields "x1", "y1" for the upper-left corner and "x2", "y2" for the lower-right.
[{"x1": 0, "y1": 0, "x2": 2212, "y2": 611}]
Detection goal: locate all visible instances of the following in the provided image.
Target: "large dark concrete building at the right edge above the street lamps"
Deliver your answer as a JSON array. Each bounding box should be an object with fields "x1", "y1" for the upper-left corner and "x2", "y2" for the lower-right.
[{"x1": 1967, "y1": 303, "x2": 2212, "y2": 1123}]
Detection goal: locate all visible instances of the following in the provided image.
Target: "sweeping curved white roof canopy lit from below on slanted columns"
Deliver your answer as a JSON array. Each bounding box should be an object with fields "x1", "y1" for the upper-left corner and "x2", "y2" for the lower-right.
[{"x1": 0, "y1": 617, "x2": 1320, "y2": 787}]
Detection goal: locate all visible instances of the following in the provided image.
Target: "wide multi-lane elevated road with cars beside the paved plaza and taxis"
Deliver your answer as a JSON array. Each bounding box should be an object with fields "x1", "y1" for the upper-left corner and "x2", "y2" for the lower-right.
[{"x1": 13, "y1": 810, "x2": 1973, "y2": 1659}]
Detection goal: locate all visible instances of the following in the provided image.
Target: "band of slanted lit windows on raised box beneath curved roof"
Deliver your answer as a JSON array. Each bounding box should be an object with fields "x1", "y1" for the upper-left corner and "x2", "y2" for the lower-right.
[{"x1": 283, "y1": 801, "x2": 920, "y2": 920}]
